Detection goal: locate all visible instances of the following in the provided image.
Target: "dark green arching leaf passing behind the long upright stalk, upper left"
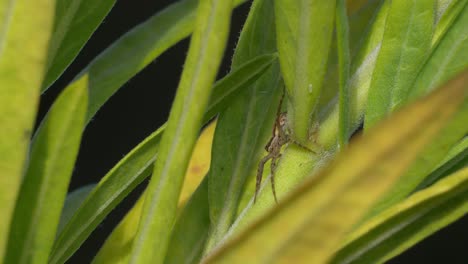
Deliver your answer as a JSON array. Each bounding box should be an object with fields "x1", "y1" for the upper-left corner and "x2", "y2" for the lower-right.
[{"x1": 38, "y1": 0, "x2": 246, "y2": 126}]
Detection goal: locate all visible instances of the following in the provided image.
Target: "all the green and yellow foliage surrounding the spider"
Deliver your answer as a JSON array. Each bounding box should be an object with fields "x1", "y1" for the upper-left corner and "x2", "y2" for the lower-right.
[{"x1": 0, "y1": 0, "x2": 468, "y2": 263}]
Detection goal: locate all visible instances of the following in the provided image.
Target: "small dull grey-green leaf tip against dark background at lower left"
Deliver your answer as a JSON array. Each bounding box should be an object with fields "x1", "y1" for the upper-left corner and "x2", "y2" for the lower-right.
[{"x1": 57, "y1": 184, "x2": 96, "y2": 234}]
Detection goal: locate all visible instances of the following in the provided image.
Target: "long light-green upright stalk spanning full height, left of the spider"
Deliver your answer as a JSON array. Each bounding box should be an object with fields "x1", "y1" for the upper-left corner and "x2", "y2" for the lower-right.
[{"x1": 129, "y1": 0, "x2": 232, "y2": 263}]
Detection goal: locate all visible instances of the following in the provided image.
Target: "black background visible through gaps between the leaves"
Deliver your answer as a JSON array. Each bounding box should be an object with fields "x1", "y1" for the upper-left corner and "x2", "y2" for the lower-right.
[{"x1": 38, "y1": 0, "x2": 468, "y2": 263}]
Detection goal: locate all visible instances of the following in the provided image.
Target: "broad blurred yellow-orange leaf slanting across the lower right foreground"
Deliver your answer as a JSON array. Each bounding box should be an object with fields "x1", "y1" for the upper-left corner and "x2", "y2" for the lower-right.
[{"x1": 204, "y1": 69, "x2": 468, "y2": 263}]
